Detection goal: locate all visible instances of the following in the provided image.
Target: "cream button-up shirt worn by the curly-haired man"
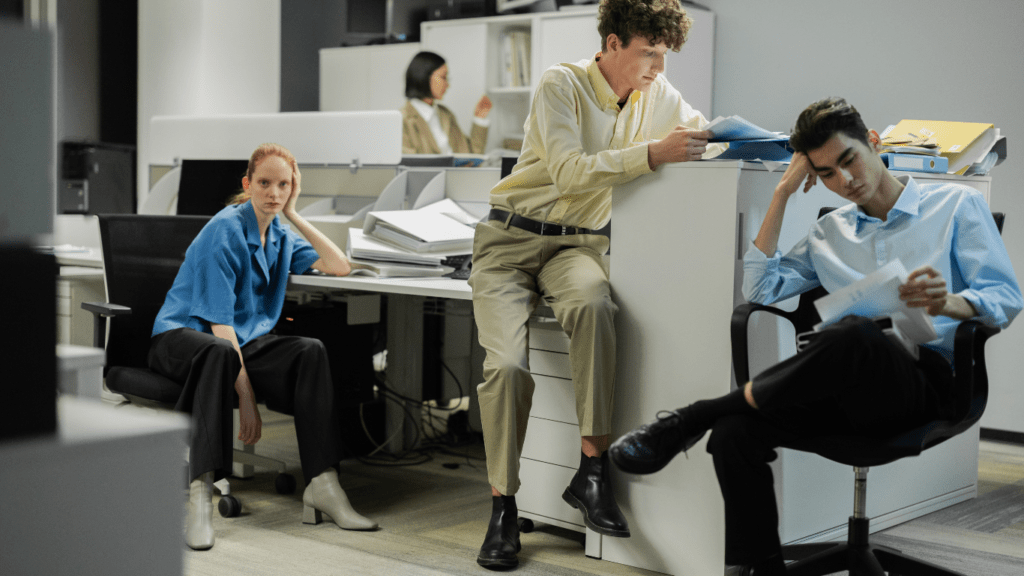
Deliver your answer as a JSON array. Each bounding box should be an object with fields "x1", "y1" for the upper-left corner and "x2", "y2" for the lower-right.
[{"x1": 490, "y1": 56, "x2": 724, "y2": 229}]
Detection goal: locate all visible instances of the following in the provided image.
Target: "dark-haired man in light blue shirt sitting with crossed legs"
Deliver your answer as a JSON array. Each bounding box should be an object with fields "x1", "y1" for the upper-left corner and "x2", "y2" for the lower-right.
[{"x1": 609, "y1": 98, "x2": 1024, "y2": 576}]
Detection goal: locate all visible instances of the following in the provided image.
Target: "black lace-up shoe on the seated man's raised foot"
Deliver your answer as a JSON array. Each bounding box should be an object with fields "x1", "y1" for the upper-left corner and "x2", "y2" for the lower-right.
[{"x1": 608, "y1": 408, "x2": 708, "y2": 474}]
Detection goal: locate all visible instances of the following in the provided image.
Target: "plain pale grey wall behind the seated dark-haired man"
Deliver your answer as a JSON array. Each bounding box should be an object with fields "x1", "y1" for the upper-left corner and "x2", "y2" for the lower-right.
[{"x1": 700, "y1": 0, "x2": 1024, "y2": 431}]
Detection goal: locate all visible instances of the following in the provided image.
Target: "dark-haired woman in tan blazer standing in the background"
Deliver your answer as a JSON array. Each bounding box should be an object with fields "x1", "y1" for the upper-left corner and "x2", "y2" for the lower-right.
[{"x1": 401, "y1": 51, "x2": 490, "y2": 155}]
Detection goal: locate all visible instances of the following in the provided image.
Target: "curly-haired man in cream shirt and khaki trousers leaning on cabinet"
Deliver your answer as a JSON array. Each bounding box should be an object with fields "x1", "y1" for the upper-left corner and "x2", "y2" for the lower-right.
[{"x1": 469, "y1": 0, "x2": 720, "y2": 569}]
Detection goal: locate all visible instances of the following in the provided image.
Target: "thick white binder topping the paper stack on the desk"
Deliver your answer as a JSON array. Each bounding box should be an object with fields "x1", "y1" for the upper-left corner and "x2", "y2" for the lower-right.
[{"x1": 362, "y1": 209, "x2": 473, "y2": 253}]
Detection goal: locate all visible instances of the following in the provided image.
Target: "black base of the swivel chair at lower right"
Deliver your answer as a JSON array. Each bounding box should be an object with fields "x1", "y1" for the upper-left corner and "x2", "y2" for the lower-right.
[{"x1": 782, "y1": 517, "x2": 965, "y2": 576}]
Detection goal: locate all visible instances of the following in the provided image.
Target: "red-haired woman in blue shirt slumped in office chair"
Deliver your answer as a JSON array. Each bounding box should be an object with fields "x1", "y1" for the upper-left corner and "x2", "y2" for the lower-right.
[{"x1": 148, "y1": 143, "x2": 377, "y2": 550}]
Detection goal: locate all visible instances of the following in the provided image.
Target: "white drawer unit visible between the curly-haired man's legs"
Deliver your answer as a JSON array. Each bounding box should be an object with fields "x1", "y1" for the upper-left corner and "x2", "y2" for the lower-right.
[{"x1": 516, "y1": 317, "x2": 601, "y2": 558}]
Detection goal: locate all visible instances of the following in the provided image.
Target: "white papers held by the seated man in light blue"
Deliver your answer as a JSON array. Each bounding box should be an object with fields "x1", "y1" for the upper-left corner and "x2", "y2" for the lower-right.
[{"x1": 798, "y1": 259, "x2": 938, "y2": 358}]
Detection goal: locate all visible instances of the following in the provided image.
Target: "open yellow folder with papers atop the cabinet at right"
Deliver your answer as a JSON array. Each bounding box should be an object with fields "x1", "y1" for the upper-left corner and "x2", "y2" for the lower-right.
[{"x1": 883, "y1": 120, "x2": 998, "y2": 174}]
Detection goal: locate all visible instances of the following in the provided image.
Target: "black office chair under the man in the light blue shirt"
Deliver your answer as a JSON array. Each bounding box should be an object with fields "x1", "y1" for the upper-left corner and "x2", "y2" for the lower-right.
[{"x1": 731, "y1": 208, "x2": 1004, "y2": 576}]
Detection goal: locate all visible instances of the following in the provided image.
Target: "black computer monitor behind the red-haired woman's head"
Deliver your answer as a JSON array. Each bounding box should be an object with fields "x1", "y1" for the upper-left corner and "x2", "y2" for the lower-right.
[{"x1": 177, "y1": 160, "x2": 249, "y2": 216}]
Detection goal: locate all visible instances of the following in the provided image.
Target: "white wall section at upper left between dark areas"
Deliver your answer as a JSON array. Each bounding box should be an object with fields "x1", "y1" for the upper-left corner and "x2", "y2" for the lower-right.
[{"x1": 138, "y1": 0, "x2": 281, "y2": 206}]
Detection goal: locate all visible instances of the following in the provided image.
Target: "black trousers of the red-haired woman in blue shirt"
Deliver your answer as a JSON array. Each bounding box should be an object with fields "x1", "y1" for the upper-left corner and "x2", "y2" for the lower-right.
[{"x1": 148, "y1": 328, "x2": 342, "y2": 483}]
